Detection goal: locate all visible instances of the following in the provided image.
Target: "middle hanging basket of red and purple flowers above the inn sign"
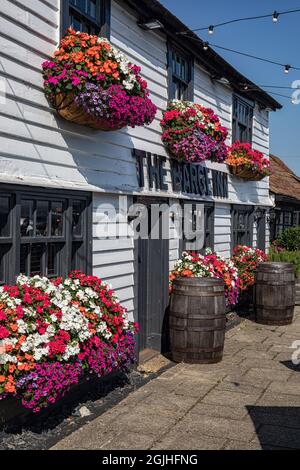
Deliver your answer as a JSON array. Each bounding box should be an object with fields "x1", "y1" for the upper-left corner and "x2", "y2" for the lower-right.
[{"x1": 161, "y1": 100, "x2": 228, "y2": 163}]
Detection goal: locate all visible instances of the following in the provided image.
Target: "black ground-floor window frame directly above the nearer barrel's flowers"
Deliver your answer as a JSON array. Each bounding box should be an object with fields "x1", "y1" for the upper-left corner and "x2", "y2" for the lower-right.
[{"x1": 179, "y1": 201, "x2": 215, "y2": 257}]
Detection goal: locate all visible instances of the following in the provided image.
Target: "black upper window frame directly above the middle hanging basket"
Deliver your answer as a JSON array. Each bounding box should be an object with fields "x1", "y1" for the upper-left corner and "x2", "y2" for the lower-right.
[{"x1": 167, "y1": 40, "x2": 194, "y2": 101}]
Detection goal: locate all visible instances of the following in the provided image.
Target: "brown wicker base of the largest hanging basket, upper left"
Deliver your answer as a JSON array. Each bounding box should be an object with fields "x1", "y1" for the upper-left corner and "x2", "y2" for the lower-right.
[{"x1": 55, "y1": 93, "x2": 125, "y2": 132}]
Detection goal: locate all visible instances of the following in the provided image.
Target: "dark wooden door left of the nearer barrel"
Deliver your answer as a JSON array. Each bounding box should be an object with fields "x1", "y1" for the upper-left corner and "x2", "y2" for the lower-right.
[{"x1": 136, "y1": 198, "x2": 169, "y2": 351}]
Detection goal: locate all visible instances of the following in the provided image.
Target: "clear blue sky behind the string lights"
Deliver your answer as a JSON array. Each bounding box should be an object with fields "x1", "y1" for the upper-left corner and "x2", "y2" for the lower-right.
[{"x1": 161, "y1": 0, "x2": 300, "y2": 176}]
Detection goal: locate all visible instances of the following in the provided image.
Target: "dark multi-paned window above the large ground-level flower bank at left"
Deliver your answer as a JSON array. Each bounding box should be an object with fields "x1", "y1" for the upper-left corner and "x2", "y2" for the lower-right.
[{"x1": 0, "y1": 188, "x2": 90, "y2": 284}]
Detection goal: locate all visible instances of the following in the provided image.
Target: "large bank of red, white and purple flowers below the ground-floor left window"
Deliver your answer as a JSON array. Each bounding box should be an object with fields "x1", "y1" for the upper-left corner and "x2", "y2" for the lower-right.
[{"x1": 0, "y1": 272, "x2": 137, "y2": 412}]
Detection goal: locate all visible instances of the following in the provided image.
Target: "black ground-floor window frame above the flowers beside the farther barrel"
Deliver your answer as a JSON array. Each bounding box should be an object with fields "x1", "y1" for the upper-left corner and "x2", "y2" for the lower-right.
[{"x1": 231, "y1": 204, "x2": 255, "y2": 251}]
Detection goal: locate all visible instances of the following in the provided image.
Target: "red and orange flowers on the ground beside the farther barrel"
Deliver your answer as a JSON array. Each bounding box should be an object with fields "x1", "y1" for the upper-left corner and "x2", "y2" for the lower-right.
[{"x1": 231, "y1": 245, "x2": 268, "y2": 292}]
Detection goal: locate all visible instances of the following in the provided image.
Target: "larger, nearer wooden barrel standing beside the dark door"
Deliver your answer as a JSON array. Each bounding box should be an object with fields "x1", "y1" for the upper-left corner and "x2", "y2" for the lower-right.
[{"x1": 169, "y1": 278, "x2": 226, "y2": 364}]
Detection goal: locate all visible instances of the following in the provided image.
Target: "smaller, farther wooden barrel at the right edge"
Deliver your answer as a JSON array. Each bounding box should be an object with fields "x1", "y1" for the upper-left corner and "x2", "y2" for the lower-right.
[{"x1": 255, "y1": 263, "x2": 295, "y2": 325}]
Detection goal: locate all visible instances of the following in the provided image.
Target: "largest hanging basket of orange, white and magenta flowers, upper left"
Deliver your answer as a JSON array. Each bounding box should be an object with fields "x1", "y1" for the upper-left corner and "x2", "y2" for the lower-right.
[{"x1": 43, "y1": 29, "x2": 157, "y2": 131}]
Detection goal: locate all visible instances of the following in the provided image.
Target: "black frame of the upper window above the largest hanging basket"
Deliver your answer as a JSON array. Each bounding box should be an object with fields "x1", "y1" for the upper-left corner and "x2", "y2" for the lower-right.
[{"x1": 60, "y1": 0, "x2": 111, "y2": 39}]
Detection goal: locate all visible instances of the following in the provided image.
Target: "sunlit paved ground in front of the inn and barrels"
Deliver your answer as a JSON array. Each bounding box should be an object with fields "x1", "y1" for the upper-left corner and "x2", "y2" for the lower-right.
[{"x1": 53, "y1": 307, "x2": 300, "y2": 450}]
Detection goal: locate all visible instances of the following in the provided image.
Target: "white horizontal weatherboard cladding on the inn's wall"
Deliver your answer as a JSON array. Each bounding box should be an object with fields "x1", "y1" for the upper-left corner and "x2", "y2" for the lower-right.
[{"x1": 0, "y1": 0, "x2": 275, "y2": 313}]
